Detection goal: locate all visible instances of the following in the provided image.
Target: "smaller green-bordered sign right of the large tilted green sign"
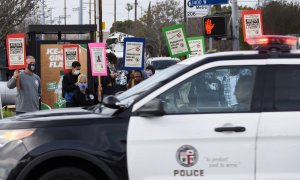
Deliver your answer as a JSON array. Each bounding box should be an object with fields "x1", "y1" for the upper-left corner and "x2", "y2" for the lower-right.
[{"x1": 187, "y1": 36, "x2": 205, "y2": 57}]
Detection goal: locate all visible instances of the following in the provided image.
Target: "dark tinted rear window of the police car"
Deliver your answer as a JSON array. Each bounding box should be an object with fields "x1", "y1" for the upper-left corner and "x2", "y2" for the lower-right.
[{"x1": 273, "y1": 66, "x2": 300, "y2": 111}]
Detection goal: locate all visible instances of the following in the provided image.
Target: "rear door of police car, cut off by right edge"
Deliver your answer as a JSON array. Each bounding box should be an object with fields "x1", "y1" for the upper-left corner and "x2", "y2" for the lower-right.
[{"x1": 256, "y1": 63, "x2": 300, "y2": 180}]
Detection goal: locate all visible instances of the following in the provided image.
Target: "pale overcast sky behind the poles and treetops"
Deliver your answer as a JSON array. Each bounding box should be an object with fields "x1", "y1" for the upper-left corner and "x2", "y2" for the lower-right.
[{"x1": 44, "y1": 0, "x2": 258, "y2": 31}]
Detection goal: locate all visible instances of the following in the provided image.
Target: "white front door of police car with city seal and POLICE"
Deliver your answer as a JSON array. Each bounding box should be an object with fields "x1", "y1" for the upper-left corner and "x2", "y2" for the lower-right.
[{"x1": 127, "y1": 60, "x2": 264, "y2": 180}]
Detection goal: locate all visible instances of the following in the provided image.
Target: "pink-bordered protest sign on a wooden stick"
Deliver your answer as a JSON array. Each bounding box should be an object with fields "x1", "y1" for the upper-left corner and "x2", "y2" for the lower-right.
[{"x1": 89, "y1": 43, "x2": 107, "y2": 76}]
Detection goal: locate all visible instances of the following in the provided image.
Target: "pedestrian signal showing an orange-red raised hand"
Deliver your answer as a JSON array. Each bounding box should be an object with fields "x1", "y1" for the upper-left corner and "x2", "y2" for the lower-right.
[{"x1": 203, "y1": 16, "x2": 227, "y2": 37}]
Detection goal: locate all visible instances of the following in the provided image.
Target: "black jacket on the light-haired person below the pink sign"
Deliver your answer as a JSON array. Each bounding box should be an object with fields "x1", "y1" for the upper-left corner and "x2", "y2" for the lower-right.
[{"x1": 71, "y1": 89, "x2": 98, "y2": 107}]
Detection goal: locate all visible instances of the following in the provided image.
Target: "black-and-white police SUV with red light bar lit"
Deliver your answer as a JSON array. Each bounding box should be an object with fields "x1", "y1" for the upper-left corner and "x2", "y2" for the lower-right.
[{"x1": 0, "y1": 37, "x2": 300, "y2": 180}]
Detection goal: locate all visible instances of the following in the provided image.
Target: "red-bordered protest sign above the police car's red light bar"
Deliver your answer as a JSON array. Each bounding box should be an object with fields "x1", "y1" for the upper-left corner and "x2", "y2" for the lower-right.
[{"x1": 242, "y1": 10, "x2": 263, "y2": 42}]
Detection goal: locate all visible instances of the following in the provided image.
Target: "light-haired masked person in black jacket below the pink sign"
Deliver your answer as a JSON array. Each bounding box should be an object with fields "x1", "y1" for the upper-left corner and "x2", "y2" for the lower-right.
[{"x1": 71, "y1": 74, "x2": 98, "y2": 107}]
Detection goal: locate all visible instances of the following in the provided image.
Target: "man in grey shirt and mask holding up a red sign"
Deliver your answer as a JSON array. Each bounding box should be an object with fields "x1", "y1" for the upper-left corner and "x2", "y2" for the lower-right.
[{"x1": 7, "y1": 56, "x2": 41, "y2": 115}]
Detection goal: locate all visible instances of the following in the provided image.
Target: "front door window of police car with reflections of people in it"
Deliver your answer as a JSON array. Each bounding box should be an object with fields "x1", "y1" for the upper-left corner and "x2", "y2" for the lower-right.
[{"x1": 158, "y1": 66, "x2": 256, "y2": 114}]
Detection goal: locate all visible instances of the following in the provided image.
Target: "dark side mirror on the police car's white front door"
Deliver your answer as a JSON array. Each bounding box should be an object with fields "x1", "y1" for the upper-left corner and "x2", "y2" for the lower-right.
[{"x1": 134, "y1": 98, "x2": 166, "y2": 117}]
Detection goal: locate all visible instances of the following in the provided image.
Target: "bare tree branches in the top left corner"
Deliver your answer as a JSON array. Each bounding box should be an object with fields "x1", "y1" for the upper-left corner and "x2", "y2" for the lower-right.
[{"x1": 0, "y1": 0, "x2": 38, "y2": 46}]
